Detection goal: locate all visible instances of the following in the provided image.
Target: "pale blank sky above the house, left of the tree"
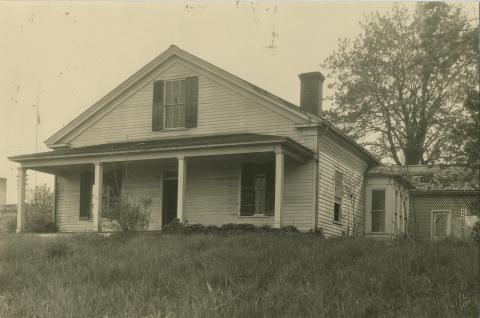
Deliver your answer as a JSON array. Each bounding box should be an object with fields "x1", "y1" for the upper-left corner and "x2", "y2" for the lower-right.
[{"x1": 0, "y1": 1, "x2": 478, "y2": 203}]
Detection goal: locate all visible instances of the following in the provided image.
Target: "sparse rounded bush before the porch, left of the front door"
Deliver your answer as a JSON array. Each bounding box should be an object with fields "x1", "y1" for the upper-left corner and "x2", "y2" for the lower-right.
[{"x1": 102, "y1": 195, "x2": 152, "y2": 234}]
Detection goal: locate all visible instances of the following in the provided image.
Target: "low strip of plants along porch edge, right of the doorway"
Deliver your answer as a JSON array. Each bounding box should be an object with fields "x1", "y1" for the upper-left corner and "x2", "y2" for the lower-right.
[{"x1": 162, "y1": 220, "x2": 298, "y2": 235}]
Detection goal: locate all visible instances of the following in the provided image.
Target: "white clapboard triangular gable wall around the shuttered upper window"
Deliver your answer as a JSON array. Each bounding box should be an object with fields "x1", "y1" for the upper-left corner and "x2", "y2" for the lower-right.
[{"x1": 67, "y1": 62, "x2": 313, "y2": 152}]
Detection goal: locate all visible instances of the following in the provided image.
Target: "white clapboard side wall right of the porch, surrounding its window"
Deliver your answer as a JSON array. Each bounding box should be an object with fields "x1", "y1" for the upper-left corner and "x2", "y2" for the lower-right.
[{"x1": 317, "y1": 133, "x2": 367, "y2": 236}]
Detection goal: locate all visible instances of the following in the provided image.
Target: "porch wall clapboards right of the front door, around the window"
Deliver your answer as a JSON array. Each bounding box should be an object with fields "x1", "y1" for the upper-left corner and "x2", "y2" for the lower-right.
[{"x1": 184, "y1": 154, "x2": 313, "y2": 231}]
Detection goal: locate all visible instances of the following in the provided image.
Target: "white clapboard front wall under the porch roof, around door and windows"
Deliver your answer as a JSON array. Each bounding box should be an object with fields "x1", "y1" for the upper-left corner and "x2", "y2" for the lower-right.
[{"x1": 52, "y1": 158, "x2": 314, "y2": 232}]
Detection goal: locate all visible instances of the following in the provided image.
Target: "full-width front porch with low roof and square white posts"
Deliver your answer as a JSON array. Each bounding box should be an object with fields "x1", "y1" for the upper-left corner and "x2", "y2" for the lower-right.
[{"x1": 11, "y1": 134, "x2": 314, "y2": 232}]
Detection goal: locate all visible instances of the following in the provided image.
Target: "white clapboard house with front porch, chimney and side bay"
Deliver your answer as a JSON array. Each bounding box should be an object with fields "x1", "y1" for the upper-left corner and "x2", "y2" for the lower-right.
[{"x1": 10, "y1": 45, "x2": 478, "y2": 237}]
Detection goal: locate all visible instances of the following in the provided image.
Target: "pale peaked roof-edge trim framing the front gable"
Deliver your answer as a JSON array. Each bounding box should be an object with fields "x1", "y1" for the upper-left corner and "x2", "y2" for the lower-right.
[{"x1": 45, "y1": 45, "x2": 322, "y2": 148}]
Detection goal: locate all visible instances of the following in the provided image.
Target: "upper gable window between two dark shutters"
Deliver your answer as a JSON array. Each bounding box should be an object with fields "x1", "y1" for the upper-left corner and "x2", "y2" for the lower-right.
[{"x1": 163, "y1": 79, "x2": 185, "y2": 128}]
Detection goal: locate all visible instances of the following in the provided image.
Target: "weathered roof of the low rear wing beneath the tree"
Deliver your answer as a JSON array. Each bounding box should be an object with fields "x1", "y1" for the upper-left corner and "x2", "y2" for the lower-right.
[{"x1": 368, "y1": 165, "x2": 479, "y2": 192}]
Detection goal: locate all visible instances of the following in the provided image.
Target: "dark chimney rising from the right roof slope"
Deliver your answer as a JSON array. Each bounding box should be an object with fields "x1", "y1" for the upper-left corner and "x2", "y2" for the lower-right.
[{"x1": 298, "y1": 72, "x2": 325, "y2": 116}]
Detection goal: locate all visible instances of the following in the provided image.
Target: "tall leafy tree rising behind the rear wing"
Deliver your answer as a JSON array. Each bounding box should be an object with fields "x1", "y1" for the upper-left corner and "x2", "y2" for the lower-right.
[{"x1": 324, "y1": 2, "x2": 478, "y2": 164}]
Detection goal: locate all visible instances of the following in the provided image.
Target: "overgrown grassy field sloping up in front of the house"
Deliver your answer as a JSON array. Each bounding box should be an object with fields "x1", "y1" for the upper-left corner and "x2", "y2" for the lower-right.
[{"x1": 0, "y1": 233, "x2": 479, "y2": 317}]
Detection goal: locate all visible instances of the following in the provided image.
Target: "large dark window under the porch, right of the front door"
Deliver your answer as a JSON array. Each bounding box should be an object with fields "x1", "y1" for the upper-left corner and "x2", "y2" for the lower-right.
[{"x1": 240, "y1": 162, "x2": 275, "y2": 216}]
